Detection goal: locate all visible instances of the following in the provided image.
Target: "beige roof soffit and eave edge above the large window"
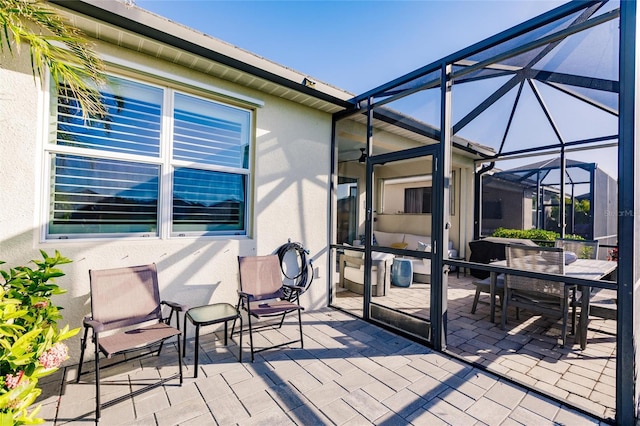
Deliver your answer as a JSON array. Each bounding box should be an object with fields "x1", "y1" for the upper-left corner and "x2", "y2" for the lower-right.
[{"x1": 51, "y1": 0, "x2": 353, "y2": 114}]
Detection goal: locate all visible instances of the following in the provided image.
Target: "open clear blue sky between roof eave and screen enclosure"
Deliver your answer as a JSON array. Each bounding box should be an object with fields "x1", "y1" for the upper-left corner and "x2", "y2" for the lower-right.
[{"x1": 135, "y1": 0, "x2": 566, "y2": 94}]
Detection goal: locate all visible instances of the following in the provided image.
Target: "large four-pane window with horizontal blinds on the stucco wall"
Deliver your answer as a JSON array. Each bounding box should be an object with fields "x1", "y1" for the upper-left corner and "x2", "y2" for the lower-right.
[{"x1": 47, "y1": 77, "x2": 251, "y2": 238}]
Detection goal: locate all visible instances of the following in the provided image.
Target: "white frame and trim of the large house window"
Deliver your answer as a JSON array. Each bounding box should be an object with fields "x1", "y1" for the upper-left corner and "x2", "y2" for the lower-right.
[{"x1": 39, "y1": 67, "x2": 264, "y2": 243}]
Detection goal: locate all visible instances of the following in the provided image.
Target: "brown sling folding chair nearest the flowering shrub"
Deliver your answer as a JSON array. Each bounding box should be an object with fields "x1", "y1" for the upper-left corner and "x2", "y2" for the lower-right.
[{"x1": 76, "y1": 264, "x2": 184, "y2": 420}]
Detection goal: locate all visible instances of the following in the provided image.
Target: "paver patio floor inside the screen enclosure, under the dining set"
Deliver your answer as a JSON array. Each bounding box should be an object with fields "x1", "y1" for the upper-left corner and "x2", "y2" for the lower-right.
[{"x1": 335, "y1": 274, "x2": 616, "y2": 419}]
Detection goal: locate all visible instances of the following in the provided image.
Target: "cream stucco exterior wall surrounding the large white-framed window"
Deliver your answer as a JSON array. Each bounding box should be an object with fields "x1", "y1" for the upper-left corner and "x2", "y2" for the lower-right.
[{"x1": 0, "y1": 43, "x2": 331, "y2": 362}]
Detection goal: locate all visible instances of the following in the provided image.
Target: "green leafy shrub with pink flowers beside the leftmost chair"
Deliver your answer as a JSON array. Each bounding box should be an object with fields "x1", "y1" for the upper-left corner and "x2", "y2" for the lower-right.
[{"x1": 0, "y1": 250, "x2": 80, "y2": 426}]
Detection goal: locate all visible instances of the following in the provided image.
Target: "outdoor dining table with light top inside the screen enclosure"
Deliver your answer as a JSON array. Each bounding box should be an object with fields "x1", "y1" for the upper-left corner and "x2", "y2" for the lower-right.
[{"x1": 489, "y1": 259, "x2": 618, "y2": 349}]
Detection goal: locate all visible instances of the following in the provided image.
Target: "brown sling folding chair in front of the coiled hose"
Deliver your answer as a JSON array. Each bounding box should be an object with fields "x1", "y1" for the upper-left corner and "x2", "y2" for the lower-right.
[{"x1": 231, "y1": 255, "x2": 304, "y2": 362}]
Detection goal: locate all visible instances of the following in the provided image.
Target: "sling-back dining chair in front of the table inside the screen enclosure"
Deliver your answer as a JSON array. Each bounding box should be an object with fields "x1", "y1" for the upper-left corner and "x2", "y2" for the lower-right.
[{"x1": 502, "y1": 245, "x2": 576, "y2": 347}]
